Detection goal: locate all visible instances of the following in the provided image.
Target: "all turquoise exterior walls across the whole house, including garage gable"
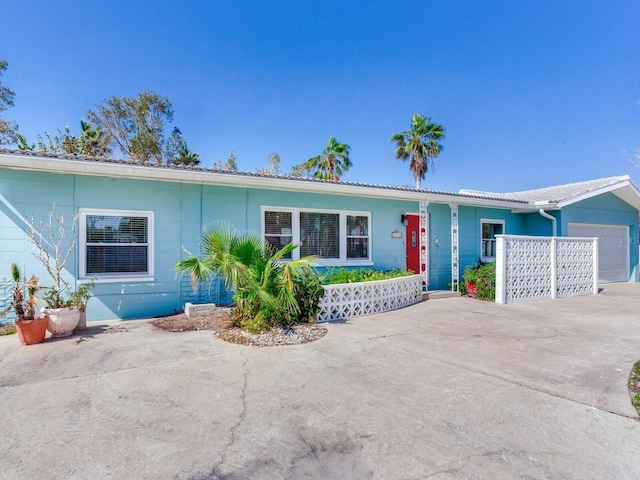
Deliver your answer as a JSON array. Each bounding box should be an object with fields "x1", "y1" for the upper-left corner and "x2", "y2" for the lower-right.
[{"x1": 0, "y1": 166, "x2": 639, "y2": 320}]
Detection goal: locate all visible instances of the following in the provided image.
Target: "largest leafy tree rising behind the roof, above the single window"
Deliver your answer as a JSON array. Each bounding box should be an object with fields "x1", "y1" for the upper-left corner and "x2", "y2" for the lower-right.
[{"x1": 87, "y1": 90, "x2": 195, "y2": 163}]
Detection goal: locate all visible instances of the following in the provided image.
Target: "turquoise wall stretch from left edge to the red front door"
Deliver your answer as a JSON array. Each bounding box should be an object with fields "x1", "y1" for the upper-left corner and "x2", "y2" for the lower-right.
[{"x1": 0, "y1": 170, "x2": 417, "y2": 321}]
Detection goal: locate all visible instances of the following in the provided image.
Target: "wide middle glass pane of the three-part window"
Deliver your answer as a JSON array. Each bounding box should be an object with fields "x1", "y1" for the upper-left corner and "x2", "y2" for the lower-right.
[{"x1": 300, "y1": 212, "x2": 340, "y2": 258}]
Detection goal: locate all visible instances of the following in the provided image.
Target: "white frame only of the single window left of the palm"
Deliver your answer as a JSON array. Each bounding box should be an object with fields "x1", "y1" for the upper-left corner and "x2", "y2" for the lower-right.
[{"x1": 78, "y1": 208, "x2": 155, "y2": 283}]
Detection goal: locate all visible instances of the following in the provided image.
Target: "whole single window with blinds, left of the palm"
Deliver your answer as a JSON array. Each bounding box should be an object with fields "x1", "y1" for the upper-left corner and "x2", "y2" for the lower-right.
[{"x1": 79, "y1": 209, "x2": 153, "y2": 280}]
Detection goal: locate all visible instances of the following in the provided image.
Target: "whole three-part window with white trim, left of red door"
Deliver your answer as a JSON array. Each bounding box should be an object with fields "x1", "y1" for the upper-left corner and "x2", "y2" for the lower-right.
[{"x1": 262, "y1": 207, "x2": 371, "y2": 265}]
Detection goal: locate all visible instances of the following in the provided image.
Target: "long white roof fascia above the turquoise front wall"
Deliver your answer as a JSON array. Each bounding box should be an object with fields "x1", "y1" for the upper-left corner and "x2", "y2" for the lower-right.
[{"x1": 0, "y1": 153, "x2": 527, "y2": 210}]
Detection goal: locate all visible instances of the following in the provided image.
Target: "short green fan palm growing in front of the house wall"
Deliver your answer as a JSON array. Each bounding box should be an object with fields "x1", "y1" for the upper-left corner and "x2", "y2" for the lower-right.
[{"x1": 174, "y1": 225, "x2": 315, "y2": 333}]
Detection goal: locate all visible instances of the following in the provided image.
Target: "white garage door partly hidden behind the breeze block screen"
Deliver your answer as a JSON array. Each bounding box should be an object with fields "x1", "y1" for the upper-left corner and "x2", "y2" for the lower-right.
[{"x1": 568, "y1": 223, "x2": 629, "y2": 283}]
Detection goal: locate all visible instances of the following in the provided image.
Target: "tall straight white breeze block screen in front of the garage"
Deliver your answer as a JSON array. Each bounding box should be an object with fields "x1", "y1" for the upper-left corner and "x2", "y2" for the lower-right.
[{"x1": 496, "y1": 235, "x2": 598, "y2": 303}]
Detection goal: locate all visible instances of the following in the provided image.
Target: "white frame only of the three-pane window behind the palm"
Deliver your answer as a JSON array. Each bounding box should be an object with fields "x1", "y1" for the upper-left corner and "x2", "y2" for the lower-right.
[{"x1": 260, "y1": 205, "x2": 373, "y2": 267}]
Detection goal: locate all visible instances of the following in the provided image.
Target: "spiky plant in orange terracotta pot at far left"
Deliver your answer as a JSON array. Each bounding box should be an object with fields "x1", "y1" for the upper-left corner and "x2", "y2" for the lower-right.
[{"x1": 0, "y1": 263, "x2": 48, "y2": 345}]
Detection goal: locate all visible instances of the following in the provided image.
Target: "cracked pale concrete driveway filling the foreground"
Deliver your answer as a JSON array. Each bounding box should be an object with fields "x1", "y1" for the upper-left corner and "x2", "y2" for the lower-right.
[{"x1": 0, "y1": 284, "x2": 640, "y2": 480}]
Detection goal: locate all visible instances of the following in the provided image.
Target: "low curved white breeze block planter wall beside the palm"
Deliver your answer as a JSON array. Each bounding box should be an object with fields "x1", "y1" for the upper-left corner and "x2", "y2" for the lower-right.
[{"x1": 318, "y1": 275, "x2": 422, "y2": 322}]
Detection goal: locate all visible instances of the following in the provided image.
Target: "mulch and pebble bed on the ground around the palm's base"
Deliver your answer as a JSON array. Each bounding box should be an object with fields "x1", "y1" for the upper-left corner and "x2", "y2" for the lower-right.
[{"x1": 151, "y1": 308, "x2": 327, "y2": 347}]
